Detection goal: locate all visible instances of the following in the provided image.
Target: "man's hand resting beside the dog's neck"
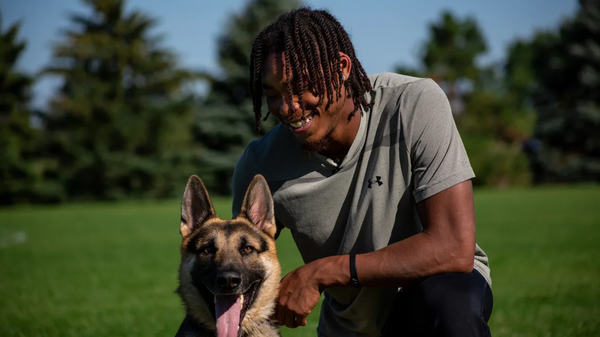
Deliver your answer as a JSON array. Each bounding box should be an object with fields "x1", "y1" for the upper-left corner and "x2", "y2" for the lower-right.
[{"x1": 275, "y1": 261, "x2": 321, "y2": 328}]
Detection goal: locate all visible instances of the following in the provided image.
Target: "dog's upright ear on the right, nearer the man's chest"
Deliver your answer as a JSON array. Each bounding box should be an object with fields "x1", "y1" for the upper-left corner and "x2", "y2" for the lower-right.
[{"x1": 240, "y1": 174, "x2": 277, "y2": 237}]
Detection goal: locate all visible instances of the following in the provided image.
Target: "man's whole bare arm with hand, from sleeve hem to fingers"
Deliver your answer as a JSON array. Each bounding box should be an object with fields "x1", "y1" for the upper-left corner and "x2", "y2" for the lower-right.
[{"x1": 277, "y1": 180, "x2": 475, "y2": 328}]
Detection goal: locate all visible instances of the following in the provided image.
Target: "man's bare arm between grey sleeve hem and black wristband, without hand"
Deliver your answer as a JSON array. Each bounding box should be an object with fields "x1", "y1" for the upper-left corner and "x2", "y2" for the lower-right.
[{"x1": 356, "y1": 180, "x2": 475, "y2": 287}]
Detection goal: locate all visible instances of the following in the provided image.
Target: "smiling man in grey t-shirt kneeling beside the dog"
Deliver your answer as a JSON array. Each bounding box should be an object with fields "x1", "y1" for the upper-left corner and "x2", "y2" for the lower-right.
[{"x1": 233, "y1": 8, "x2": 492, "y2": 336}]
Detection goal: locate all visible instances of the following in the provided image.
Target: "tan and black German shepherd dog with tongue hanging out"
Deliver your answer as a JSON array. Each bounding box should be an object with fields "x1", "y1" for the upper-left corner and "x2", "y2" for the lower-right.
[{"x1": 176, "y1": 175, "x2": 281, "y2": 337}]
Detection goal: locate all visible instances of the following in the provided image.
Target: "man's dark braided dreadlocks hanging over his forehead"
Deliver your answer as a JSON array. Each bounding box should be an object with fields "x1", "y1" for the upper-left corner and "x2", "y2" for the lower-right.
[{"x1": 250, "y1": 7, "x2": 373, "y2": 131}]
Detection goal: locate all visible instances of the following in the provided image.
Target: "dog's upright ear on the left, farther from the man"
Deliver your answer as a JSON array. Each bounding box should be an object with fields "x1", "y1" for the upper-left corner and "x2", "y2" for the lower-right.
[{"x1": 179, "y1": 175, "x2": 217, "y2": 238}]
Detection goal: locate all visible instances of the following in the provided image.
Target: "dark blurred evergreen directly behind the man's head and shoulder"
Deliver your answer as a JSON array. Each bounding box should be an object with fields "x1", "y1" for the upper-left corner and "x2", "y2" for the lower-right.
[{"x1": 196, "y1": 0, "x2": 300, "y2": 194}]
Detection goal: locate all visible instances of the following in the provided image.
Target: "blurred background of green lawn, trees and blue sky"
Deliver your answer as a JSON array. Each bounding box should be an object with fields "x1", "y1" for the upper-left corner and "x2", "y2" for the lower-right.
[{"x1": 0, "y1": 0, "x2": 600, "y2": 336}]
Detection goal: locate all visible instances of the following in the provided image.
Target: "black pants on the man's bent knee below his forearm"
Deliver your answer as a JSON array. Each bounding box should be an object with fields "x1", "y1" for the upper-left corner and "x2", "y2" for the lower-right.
[{"x1": 384, "y1": 270, "x2": 493, "y2": 337}]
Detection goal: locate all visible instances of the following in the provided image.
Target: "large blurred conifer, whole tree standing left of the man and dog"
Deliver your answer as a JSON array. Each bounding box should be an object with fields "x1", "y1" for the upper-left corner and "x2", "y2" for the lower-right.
[{"x1": 44, "y1": 0, "x2": 198, "y2": 199}]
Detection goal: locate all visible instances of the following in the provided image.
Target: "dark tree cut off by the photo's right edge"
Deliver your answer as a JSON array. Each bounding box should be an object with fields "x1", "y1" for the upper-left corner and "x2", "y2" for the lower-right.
[{"x1": 529, "y1": 0, "x2": 600, "y2": 182}]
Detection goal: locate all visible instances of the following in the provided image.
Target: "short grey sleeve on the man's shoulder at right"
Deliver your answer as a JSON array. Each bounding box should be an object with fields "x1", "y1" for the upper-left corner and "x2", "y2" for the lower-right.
[{"x1": 401, "y1": 79, "x2": 475, "y2": 202}]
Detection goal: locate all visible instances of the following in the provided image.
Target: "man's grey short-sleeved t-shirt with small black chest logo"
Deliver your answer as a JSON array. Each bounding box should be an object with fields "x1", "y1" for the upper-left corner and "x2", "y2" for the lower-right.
[{"x1": 233, "y1": 73, "x2": 491, "y2": 336}]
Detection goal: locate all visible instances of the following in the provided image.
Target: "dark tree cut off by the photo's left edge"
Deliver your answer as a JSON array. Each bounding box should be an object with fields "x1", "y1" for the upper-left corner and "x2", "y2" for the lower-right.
[{"x1": 0, "y1": 13, "x2": 42, "y2": 205}]
